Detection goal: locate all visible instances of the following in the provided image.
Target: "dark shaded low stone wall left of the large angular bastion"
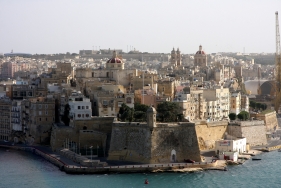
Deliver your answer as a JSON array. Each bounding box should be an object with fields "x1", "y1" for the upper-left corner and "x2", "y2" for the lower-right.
[{"x1": 51, "y1": 117, "x2": 114, "y2": 153}]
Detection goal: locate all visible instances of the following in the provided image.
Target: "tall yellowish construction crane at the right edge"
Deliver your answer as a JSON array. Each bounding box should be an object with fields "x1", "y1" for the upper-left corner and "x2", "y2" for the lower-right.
[{"x1": 273, "y1": 12, "x2": 281, "y2": 113}]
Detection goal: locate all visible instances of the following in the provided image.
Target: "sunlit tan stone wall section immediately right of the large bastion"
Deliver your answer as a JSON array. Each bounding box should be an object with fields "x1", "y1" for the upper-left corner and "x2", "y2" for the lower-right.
[{"x1": 195, "y1": 121, "x2": 228, "y2": 150}]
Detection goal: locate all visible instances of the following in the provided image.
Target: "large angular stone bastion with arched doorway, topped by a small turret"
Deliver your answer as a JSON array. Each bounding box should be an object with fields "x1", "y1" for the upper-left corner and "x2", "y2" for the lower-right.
[{"x1": 108, "y1": 123, "x2": 201, "y2": 163}]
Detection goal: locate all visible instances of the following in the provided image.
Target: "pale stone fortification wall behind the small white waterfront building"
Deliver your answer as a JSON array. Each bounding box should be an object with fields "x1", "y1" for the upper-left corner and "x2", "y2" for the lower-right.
[{"x1": 227, "y1": 121, "x2": 267, "y2": 146}]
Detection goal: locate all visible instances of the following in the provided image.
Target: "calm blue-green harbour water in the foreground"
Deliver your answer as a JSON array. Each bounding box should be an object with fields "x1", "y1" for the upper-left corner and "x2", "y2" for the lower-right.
[{"x1": 0, "y1": 148, "x2": 281, "y2": 188}]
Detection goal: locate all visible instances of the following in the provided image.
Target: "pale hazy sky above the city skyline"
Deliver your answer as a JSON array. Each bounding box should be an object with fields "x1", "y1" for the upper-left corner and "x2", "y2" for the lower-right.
[{"x1": 0, "y1": 0, "x2": 281, "y2": 54}]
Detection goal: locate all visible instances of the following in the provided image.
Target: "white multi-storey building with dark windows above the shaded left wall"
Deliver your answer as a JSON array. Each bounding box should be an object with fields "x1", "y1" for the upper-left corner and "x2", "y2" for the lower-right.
[{"x1": 68, "y1": 92, "x2": 92, "y2": 120}]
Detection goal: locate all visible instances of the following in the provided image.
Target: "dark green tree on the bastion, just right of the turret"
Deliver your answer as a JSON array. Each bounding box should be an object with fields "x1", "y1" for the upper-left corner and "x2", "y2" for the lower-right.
[{"x1": 157, "y1": 101, "x2": 179, "y2": 122}]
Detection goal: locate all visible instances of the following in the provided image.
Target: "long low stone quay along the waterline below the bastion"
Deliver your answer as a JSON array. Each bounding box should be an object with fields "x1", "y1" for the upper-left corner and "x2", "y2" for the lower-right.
[{"x1": 0, "y1": 144, "x2": 222, "y2": 174}]
